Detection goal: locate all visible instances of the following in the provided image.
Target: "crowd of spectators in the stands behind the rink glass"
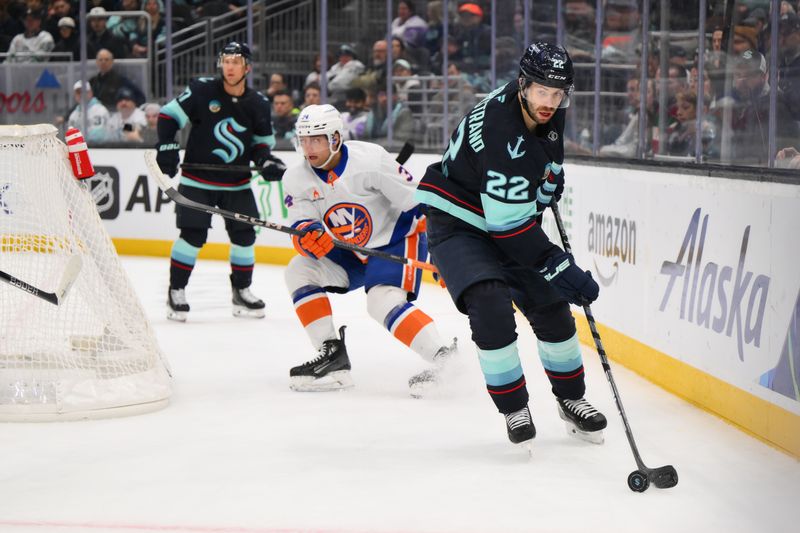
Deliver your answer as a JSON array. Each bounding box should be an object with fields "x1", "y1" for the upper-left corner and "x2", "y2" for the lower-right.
[{"x1": 6, "y1": 0, "x2": 800, "y2": 166}]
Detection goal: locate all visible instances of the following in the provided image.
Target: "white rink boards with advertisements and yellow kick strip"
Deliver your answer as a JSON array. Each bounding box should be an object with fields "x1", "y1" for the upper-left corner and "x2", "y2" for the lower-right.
[{"x1": 87, "y1": 150, "x2": 800, "y2": 457}]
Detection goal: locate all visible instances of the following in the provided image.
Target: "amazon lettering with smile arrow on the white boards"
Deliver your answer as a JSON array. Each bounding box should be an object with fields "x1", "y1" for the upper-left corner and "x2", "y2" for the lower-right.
[{"x1": 587, "y1": 213, "x2": 636, "y2": 287}]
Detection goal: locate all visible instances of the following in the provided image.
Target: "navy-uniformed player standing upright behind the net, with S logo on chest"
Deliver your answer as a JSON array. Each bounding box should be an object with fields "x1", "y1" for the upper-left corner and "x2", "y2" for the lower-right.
[{"x1": 156, "y1": 42, "x2": 285, "y2": 322}]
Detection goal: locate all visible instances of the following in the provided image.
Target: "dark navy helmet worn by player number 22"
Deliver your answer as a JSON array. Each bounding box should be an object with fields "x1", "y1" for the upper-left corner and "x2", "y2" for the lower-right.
[{"x1": 519, "y1": 42, "x2": 575, "y2": 107}]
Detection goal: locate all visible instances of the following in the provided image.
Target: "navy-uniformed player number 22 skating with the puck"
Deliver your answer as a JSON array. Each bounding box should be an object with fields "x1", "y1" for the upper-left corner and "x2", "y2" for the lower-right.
[{"x1": 416, "y1": 43, "x2": 606, "y2": 444}]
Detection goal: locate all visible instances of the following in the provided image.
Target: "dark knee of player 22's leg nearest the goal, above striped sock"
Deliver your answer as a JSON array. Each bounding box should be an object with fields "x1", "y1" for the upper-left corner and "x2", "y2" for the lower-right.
[{"x1": 461, "y1": 280, "x2": 517, "y2": 350}]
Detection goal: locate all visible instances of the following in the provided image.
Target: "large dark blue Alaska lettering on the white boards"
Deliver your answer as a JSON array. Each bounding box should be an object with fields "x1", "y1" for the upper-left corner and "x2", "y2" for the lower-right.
[{"x1": 659, "y1": 208, "x2": 770, "y2": 361}]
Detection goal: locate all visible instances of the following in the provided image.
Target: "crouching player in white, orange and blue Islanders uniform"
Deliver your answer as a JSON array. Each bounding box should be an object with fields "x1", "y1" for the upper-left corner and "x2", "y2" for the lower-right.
[{"x1": 283, "y1": 105, "x2": 456, "y2": 397}]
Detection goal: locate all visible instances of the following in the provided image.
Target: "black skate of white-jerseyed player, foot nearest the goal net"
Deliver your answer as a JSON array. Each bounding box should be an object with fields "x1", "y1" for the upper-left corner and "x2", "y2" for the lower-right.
[{"x1": 289, "y1": 326, "x2": 353, "y2": 392}]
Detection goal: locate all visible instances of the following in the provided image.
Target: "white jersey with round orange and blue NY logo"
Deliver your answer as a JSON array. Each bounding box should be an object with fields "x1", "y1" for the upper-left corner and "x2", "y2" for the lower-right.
[{"x1": 283, "y1": 141, "x2": 422, "y2": 248}]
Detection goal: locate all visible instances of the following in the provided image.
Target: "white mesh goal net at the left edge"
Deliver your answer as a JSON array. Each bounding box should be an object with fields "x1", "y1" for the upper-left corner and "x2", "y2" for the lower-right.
[{"x1": 0, "y1": 125, "x2": 170, "y2": 420}]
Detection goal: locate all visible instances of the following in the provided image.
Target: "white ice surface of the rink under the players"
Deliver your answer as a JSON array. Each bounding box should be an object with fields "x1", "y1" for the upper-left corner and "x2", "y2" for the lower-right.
[{"x1": 0, "y1": 258, "x2": 800, "y2": 533}]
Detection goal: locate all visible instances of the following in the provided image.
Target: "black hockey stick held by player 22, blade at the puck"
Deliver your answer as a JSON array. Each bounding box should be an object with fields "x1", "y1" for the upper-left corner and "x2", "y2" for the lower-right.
[{"x1": 550, "y1": 202, "x2": 678, "y2": 492}]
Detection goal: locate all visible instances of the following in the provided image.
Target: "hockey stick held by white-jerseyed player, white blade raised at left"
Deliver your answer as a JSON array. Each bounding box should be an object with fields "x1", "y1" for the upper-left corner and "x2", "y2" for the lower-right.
[{"x1": 144, "y1": 150, "x2": 439, "y2": 273}]
